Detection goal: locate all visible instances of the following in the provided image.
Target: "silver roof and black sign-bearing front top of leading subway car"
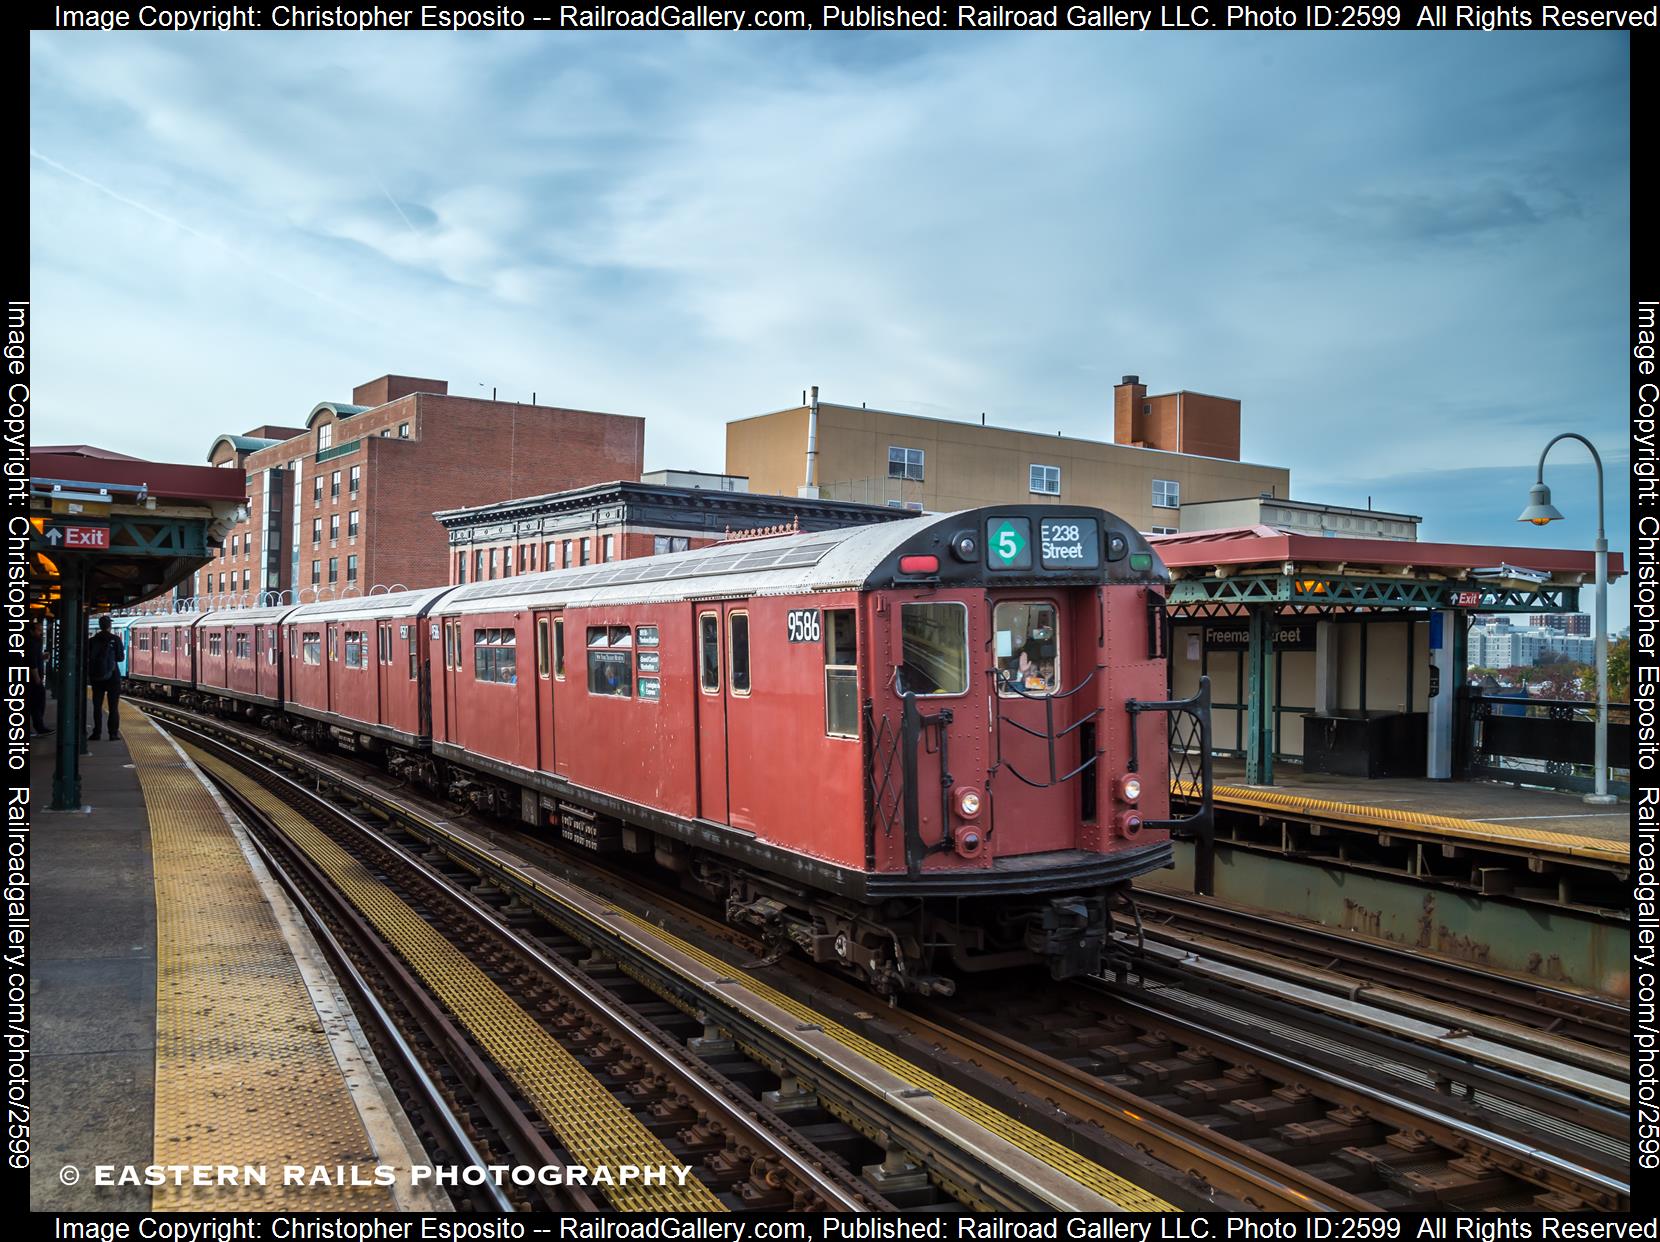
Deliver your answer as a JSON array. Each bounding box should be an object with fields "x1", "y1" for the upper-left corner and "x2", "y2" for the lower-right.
[{"x1": 432, "y1": 505, "x2": 1169, "y2": 616}]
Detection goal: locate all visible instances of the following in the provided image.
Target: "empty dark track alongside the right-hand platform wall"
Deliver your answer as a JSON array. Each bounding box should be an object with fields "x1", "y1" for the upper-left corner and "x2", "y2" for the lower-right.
[{"x1": 1135, "y1": 890, "x2": 1632, "y2": 1059}]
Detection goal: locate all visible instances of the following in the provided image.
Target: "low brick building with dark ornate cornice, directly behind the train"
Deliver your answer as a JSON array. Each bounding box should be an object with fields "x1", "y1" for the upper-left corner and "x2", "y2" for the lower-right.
[{"x1": 432, "y1": 472, "x2": 913, "y2": 583}]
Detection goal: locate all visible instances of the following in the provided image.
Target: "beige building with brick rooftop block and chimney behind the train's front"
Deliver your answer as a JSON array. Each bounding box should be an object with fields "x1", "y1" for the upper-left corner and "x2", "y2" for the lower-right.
[{"x1": 725, "y1": 375, "x2": 1291, "y2": 533}]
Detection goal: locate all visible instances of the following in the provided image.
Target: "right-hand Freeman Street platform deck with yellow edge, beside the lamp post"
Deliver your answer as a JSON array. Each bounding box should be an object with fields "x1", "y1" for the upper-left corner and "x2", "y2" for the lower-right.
[{"x1": 1213, "y1": 759, "x2": 1632, "y2": 868}]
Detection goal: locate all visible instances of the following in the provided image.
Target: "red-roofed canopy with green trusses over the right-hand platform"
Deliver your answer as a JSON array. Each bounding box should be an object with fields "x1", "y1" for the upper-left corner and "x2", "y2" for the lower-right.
[{"x1": 1149, "y1": 526, "x2": 1623, "y2": 616}]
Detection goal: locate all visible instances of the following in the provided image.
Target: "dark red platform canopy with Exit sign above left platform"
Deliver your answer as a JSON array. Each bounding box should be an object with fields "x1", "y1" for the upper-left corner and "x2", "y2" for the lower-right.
[{"x1": 28, "y1": 445, "x2": 247, "y2": 616}]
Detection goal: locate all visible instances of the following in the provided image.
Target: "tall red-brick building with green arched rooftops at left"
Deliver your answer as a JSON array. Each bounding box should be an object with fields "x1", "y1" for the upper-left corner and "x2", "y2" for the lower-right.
[{"x1": 168, "y1": 375, "x2": 646, "y2": 606}]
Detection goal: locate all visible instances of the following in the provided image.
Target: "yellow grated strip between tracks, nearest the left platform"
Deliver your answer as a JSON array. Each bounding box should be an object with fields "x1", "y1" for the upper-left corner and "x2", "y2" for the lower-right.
[{"x1": 191, "y1": 751, "x2": 725, "y2": 1212}]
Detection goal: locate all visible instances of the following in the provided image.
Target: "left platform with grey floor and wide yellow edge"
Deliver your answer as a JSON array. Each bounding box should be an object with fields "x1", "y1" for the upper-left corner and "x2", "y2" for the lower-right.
[{"x1": 30, "y1": 707, "x2": 445, "y2": 1212}]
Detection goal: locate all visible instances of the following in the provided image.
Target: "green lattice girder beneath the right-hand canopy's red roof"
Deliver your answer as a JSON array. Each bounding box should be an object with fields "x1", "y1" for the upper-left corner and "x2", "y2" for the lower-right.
[{"x1": 1169, "y1": 571, "x2": 1579, "y2": 616}]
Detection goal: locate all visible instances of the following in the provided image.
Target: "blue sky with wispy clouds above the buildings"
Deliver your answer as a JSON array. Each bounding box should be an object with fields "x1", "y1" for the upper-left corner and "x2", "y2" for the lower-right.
[{"x1": 30, "y1": 33, "x2": 1630, "y2": 628}]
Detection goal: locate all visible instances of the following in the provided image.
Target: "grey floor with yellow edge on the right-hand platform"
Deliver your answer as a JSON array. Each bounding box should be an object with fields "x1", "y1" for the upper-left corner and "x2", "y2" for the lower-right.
[{"x1": 1213, "y1": 759, "x2": 1632, "y2": 857}]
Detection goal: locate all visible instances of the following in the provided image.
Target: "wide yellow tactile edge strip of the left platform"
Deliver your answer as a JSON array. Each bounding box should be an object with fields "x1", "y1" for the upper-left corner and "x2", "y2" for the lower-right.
[{"x1": 126, "y1": 712, "x2": 392, "y2": 1212}]
